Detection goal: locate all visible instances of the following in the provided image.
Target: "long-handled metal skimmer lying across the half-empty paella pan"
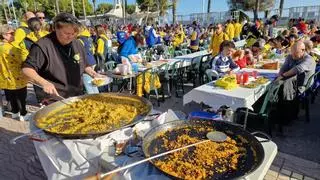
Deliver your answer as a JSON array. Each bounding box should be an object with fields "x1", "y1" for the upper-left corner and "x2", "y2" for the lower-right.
[{"x1": 101, "y1": 131, "x2": 227, "y2": 178}]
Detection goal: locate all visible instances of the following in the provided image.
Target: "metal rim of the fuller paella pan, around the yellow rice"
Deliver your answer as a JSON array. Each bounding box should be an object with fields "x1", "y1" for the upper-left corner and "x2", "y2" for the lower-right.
[{"x1": 33, "y1": 93, "x2": 152, "y2": 139}]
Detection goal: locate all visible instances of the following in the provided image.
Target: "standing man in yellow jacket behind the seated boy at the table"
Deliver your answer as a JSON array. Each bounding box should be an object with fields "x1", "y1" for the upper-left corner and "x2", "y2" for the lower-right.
[{"x1": 208, "y1": 24, "x2": 229, "y2": 56}]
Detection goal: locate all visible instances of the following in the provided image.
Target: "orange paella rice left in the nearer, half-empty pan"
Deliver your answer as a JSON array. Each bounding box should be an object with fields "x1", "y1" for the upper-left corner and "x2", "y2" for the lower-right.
[{"x1": 152, "y1": 128, "x2": 246, "y2": 179}]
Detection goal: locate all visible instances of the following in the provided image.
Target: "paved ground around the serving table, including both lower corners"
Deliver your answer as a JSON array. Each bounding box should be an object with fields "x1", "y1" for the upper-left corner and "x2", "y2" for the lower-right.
[{"x1": 0, "y1": 84, "x2": 320, "y2": 180}]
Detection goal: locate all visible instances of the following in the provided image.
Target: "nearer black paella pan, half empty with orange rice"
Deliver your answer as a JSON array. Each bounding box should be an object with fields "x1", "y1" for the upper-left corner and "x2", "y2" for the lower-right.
[{"x1": 143, "y1": 120, "x2": 264, "y2": 179}]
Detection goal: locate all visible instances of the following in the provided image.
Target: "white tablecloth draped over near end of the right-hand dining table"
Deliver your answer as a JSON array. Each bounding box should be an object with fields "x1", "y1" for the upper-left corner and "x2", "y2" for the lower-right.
[{"x1": 183, "y1": 82, "x2": 269, "y2": 110}]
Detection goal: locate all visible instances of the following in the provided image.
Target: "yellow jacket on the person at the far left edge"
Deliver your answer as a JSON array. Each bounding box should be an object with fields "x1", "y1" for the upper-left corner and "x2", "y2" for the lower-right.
[{"x1": 0, "y1": 42, "x2": 28, "y2": 90}]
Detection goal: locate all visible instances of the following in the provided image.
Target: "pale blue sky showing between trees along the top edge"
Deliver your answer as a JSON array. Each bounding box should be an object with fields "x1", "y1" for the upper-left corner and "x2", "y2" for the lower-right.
[{"x1": 97, "y1": 0, "x2": 320, "y2": 14}]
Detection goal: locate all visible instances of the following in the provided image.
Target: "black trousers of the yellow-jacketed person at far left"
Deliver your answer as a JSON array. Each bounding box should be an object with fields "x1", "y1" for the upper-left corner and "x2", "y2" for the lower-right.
[{"x1": 4, "y1": 87, "x2": 27, "y2": 116}]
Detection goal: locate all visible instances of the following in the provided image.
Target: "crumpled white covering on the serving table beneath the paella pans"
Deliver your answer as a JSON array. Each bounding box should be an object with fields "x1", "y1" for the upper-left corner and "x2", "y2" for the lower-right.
[{"x1": 30, "y1": 111, "x2": 172, "y2": 180}]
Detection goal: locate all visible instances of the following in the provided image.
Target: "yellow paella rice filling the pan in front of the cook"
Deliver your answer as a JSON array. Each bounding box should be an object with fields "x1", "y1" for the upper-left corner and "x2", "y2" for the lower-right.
[{"x1": 37, "y1": 95, "x2": 148, "y2": 134}]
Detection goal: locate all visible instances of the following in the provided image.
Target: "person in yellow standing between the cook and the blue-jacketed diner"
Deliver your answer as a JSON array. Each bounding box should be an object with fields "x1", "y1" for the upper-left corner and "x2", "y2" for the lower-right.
[{"x1": 96, "y1": 25, "x2": 108, "y2": 70}]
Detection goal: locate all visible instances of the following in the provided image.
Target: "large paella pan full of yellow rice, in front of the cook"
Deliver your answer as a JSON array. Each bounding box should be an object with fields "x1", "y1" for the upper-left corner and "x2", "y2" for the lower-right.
[{"x1": 34, "y1": 93, "x2": 152, "y2": 138}]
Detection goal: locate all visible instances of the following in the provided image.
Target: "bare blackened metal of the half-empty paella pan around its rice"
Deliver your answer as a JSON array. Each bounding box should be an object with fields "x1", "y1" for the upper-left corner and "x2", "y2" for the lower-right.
[{"x1": 142, "y1": 119, "x2": 265, "y2": 179}]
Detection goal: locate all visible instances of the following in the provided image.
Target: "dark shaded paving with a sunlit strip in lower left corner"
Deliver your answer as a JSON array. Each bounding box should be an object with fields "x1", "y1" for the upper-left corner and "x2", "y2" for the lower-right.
[{"x1": 0, "y1": 118, "x2": 46, "y2": 180}]
